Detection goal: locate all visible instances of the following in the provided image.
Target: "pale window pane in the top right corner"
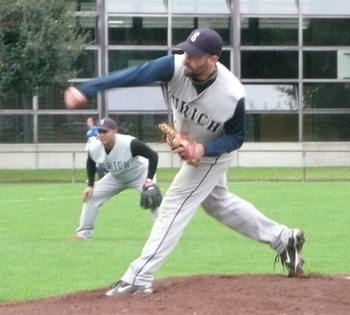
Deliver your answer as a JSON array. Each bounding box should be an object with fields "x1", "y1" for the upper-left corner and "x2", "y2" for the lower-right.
[{"x1": 302, "y1": 0, "x2": 350, "y2": 15}]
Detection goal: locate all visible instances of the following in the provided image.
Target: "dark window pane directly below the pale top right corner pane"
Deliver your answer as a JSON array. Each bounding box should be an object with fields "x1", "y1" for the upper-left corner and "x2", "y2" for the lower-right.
[{"x1": 303, "y1": 18, "x2": 350, "y2": 46}]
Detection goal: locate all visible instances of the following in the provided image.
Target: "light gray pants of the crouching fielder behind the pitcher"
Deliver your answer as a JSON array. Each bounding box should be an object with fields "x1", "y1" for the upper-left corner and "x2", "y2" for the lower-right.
[{"x1": 77, "y1": 172, "x2": 158, "y2": 239}]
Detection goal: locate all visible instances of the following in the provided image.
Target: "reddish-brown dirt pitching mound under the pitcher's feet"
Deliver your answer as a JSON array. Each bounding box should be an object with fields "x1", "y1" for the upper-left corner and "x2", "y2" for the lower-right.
[{"x1": 0, "y1": 275, "x2": 350, "y2": 315}]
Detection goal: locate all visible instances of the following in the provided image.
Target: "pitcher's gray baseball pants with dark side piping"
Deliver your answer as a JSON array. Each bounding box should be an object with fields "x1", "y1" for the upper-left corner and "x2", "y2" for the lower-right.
[{"x1": 122, "y1": 159, "x2": 291, "y2": 285}]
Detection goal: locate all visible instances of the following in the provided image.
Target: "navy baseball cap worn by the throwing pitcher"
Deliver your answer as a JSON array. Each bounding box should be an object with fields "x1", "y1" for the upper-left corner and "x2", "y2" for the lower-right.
[{"x1": 177, "y1": 28, "x2": 223, "y2": 57}]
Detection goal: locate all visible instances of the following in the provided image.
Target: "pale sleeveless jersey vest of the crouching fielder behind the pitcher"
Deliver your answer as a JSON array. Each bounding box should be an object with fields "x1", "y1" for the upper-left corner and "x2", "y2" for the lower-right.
[{"x1": 89, "y1": 134, "x2": 148, "y2": 183}]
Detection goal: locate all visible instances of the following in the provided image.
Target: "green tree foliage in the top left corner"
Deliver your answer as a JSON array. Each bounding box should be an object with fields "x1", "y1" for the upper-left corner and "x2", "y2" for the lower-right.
[{"x1": 0, "y1": 0, "x2": 87, "y2": 95}]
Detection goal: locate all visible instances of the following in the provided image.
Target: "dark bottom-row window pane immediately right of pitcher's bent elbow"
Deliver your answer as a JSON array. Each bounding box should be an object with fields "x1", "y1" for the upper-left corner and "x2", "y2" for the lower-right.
[{"x1": 244, "y1": 113, "x2": 298, "y2": 142}]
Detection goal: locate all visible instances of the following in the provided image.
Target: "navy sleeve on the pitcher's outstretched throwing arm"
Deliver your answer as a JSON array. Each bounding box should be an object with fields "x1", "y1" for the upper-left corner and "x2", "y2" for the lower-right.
[{"x1": 76, "y1": 56, "x2": 174, "y2": 98}]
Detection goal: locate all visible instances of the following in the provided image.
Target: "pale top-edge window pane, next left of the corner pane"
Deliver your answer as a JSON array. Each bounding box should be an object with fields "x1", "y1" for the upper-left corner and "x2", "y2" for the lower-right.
[{"x1": 240, "y1": 0, "x2": 303, "y2": 14}]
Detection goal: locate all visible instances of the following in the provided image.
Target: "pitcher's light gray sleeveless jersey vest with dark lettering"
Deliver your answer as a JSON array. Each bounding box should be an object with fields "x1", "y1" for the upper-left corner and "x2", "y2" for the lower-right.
[{"x1": 168, "y1": 55, "x2": 244, "y2": 162}]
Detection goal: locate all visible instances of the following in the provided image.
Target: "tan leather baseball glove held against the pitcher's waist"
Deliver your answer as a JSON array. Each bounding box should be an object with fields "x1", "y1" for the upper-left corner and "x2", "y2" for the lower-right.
[{"x1": 159, "y1": 123, "x2": 199, "y2": 166}]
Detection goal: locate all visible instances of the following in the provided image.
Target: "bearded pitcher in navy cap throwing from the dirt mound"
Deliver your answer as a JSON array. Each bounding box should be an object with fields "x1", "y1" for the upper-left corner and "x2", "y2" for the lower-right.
[{"x1": 65, "y1": 28, "x2": 304, "y2": 296}]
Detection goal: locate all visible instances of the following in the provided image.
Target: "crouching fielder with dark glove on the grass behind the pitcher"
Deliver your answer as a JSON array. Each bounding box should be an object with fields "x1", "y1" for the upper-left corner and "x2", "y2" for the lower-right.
[{"x1": 74, "y1": 117, "x2": 162, "y2": 241}]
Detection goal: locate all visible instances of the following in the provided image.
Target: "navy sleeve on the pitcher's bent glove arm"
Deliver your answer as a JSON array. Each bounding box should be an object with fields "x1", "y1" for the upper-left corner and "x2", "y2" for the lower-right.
[{"x1": 203, "y1": 97, "x2": 245, "y2": 156}]
